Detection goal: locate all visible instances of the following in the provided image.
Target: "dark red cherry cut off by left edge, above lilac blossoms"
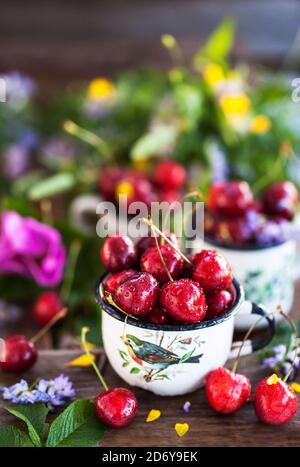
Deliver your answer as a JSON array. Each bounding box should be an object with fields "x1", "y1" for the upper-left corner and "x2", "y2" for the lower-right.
[{"x1": 0, "y1": 335, "x2": 38, "y2": 373}]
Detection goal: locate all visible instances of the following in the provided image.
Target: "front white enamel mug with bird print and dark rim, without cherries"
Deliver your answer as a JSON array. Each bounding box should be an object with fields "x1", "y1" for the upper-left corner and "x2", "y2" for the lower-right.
[{"x1": 96, "y1": 275, "x2": 275, "y2": 396}]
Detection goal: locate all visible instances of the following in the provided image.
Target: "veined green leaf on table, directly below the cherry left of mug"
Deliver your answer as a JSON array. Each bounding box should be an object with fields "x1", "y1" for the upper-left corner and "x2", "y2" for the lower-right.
[{"x1": 46, "y1": 400, "x2": 106, "y2": 447}]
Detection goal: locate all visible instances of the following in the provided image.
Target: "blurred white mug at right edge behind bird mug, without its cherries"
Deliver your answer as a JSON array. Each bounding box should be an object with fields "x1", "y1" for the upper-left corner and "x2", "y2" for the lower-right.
[{"x1": 193, "y1": 239, "x2": 298, "y2": 331}]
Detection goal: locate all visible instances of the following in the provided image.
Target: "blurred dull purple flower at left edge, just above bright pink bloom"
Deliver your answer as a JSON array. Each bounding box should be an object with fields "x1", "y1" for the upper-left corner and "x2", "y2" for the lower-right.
[{"x1": 2, "y1": 144, "x2": 31, "y2": 180}]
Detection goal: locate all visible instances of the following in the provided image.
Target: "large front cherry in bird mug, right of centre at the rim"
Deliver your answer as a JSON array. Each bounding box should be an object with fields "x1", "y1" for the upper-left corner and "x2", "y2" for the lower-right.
[{"x1": 160, "y1": 279, "x2": 206, "y2": 323}]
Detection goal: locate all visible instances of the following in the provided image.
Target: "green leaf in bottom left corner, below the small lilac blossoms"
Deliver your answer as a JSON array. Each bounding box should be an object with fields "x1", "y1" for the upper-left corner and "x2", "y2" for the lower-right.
[{"x1": 5, "y1": 404, "x2": 48, "y2": 447}]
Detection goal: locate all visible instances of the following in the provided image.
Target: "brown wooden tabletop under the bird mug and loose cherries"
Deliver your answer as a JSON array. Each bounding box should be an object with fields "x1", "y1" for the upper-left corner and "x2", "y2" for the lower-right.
[{"x1": 0, "y1": 283, "x2": 300, "y2": 447}]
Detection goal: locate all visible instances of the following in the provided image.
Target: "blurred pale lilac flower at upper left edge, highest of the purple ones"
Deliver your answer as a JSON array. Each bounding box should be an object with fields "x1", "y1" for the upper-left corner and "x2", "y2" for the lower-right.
[{"x1": 0, "y1": 71, "x2": 37, "y2": 111}]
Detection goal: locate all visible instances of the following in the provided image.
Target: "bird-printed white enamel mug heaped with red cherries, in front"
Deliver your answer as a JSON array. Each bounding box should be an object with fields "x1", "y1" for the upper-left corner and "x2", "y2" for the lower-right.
[{"x1": 96, "y1": 229, "x2": 274, "y2": 396}]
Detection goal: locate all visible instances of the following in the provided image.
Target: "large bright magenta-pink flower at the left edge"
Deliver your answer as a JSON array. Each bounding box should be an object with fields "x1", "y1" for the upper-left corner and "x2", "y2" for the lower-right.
[{"x1": 0, "y1": 211, "x2": 66, "y2": 287}]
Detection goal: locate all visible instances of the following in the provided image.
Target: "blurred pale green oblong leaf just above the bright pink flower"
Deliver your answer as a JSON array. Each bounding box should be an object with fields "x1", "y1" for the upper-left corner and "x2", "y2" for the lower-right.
[{"x1": 28, "y1": 173, "x2": 76, "y2": 201}]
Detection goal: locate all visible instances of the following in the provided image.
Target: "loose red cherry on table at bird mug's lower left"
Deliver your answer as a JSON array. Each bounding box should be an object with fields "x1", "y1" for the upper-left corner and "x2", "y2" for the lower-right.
[{"x1": 95, "y1": 388, "x2": 138, "y2": 428}]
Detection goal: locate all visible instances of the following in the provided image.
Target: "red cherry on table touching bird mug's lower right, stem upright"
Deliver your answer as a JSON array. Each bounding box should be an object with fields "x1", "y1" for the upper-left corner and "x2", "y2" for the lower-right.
[{"x1": 206, "y1": 368, "x2": 251, "y2": 414}]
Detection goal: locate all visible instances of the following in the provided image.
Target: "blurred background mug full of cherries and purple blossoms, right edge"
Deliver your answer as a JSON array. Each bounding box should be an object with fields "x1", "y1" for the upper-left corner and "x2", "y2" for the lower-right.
[{"x1": 195, "y1": 181, "x2": 298, "y2": 330}]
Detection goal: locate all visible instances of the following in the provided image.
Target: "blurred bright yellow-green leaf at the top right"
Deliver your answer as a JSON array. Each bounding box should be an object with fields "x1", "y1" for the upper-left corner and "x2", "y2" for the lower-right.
[{"x1": 194, "y1": 18, "x2": 235, "y2": 66}]
